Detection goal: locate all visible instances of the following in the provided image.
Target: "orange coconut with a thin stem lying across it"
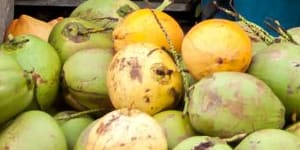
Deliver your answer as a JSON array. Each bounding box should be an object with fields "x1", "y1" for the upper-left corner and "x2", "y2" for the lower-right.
[{"x1": 113, "y1": 9, "x2": 184, "y2": 52}]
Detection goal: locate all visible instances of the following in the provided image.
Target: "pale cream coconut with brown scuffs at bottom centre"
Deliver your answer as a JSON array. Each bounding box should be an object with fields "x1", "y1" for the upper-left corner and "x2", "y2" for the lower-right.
[{"x1": 74, "y1": 108, "x2": 167, "y2": 150}]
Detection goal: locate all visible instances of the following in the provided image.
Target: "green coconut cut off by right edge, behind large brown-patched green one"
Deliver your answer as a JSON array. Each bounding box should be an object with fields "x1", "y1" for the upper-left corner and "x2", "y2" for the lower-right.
[{"x1": 248, "y1": 42, "x2": 300, "y2": 115}]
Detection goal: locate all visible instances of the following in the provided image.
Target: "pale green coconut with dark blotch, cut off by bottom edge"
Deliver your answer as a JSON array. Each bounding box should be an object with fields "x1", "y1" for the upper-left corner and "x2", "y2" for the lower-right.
[{"x1": 173, "y1": 136, "x2": 232, "y2": 150}]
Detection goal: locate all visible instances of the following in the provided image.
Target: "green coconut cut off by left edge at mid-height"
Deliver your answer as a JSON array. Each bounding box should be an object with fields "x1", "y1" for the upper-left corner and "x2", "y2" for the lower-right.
[{"x1": 0, "y1": 54, "x2": 34, "y2": 124}]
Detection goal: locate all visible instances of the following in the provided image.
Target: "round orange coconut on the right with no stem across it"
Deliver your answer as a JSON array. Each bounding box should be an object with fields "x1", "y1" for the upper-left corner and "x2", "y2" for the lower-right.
[{"x1": 181, "y1": 19, "x2": 252, "y2": 79}]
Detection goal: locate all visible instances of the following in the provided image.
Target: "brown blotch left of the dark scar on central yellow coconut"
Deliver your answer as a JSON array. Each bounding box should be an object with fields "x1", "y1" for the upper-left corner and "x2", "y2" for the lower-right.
[{"x1": 127, "y1": 57, "x2": 142, "y2": 83}]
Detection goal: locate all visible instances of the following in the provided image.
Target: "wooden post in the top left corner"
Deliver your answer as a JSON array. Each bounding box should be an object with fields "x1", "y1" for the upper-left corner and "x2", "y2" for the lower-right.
[{"x1": 0, "y1": 0, "x2": 14, "y2": 43}]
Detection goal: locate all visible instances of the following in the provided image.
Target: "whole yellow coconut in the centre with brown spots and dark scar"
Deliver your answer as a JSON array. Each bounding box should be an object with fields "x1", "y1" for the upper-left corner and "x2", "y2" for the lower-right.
[{"x1": 107, "y1": 43, "x2": 183, "y2": 114}]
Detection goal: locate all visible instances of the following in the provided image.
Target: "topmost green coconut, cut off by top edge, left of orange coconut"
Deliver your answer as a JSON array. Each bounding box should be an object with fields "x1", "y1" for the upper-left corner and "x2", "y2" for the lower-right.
[{"x1": 71, "y1": 0, "x2": 139, "y2": 28}]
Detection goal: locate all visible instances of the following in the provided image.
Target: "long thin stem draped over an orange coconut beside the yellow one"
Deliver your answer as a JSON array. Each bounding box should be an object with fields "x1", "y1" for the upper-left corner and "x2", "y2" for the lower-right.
[{"x1": 151, "y1": 10, "x2": 190, "y2": 114}]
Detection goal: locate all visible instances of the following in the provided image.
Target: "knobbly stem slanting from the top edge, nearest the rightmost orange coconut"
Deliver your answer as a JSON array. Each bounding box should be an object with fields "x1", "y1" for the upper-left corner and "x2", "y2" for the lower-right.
[{"x1": 213, "y1": 0, "x2": 275, "y2": 45}]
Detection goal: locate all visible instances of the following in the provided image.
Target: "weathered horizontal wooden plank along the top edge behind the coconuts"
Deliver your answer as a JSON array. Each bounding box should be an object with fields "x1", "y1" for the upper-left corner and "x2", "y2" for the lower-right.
[{"x1": 15, "y1": 0, "x2": 191, "y2": 12}]
